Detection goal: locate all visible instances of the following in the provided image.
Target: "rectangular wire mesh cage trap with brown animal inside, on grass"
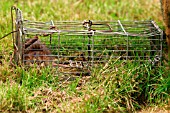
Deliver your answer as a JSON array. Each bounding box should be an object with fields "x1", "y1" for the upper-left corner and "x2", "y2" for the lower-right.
[{"x1": 11, "y1": 7, "x2": 163, "y2": 74}]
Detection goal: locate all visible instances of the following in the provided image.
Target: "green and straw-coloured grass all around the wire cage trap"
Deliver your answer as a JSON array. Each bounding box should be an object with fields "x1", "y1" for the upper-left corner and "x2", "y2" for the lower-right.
[{"x1": 0, "y1": 0, "x2": 170, "y2": 113}]
